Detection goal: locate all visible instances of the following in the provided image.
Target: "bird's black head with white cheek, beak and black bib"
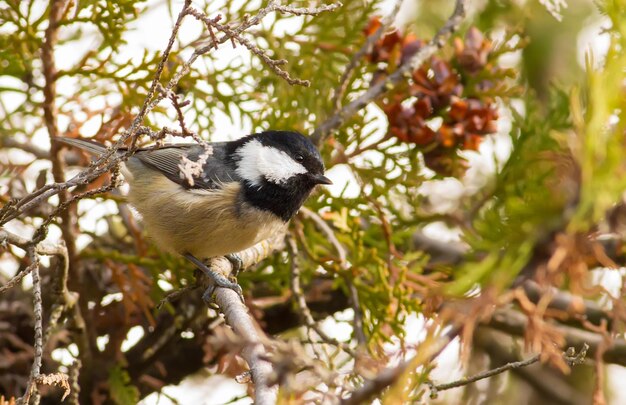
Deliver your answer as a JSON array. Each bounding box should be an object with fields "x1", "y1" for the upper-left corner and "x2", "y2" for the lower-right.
[{"x1": 231, "y1": 131, "x2": 332, "y2": 221}]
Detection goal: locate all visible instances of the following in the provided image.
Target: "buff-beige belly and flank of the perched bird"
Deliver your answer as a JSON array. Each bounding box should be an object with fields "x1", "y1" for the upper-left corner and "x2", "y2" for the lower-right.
[{"x1": 128, "y1": 165, "x2": 286, "y2": 258}]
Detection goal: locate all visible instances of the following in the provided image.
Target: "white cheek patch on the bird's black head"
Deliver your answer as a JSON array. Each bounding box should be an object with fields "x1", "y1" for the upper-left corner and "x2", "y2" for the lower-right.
[{"x1": 236, "y1": 139, "x2": 307, "y2": 186}]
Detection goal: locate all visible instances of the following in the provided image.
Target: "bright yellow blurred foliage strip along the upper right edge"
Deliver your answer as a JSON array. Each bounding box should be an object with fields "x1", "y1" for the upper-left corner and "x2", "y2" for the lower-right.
[{"x1": 571, "y1": 1, "x2": 626, "y2": 230}]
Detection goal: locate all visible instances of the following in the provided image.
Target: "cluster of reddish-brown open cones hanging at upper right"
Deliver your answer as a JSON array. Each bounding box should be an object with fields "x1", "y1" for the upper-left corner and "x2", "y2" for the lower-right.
[{"x1": 364, "y1": 18, "x2": 508, "y2": 175}]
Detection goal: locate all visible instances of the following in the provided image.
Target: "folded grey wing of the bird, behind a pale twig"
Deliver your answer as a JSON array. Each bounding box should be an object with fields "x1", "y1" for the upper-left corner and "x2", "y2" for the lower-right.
[{"x1": 133, "y1": 142, "x2": 239, "y2": 189}]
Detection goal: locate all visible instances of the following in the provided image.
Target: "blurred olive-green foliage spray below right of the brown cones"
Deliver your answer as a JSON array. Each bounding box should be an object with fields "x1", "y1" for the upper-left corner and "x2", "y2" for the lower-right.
[{"x1": 448, "y1": 92, "x2": 564, "y2": 295}]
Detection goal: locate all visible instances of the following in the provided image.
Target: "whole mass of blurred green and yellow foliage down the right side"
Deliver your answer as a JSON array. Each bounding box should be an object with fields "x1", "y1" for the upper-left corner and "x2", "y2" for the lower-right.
[{"x1": 448, "y1": 2, "x2": 626, "y2": 294}]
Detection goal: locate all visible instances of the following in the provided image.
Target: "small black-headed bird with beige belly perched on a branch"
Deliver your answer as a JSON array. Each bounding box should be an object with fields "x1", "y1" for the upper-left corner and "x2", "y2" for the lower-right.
[{"x1": 57, "y1": 131, "x2": 332, "y2": 300}]
